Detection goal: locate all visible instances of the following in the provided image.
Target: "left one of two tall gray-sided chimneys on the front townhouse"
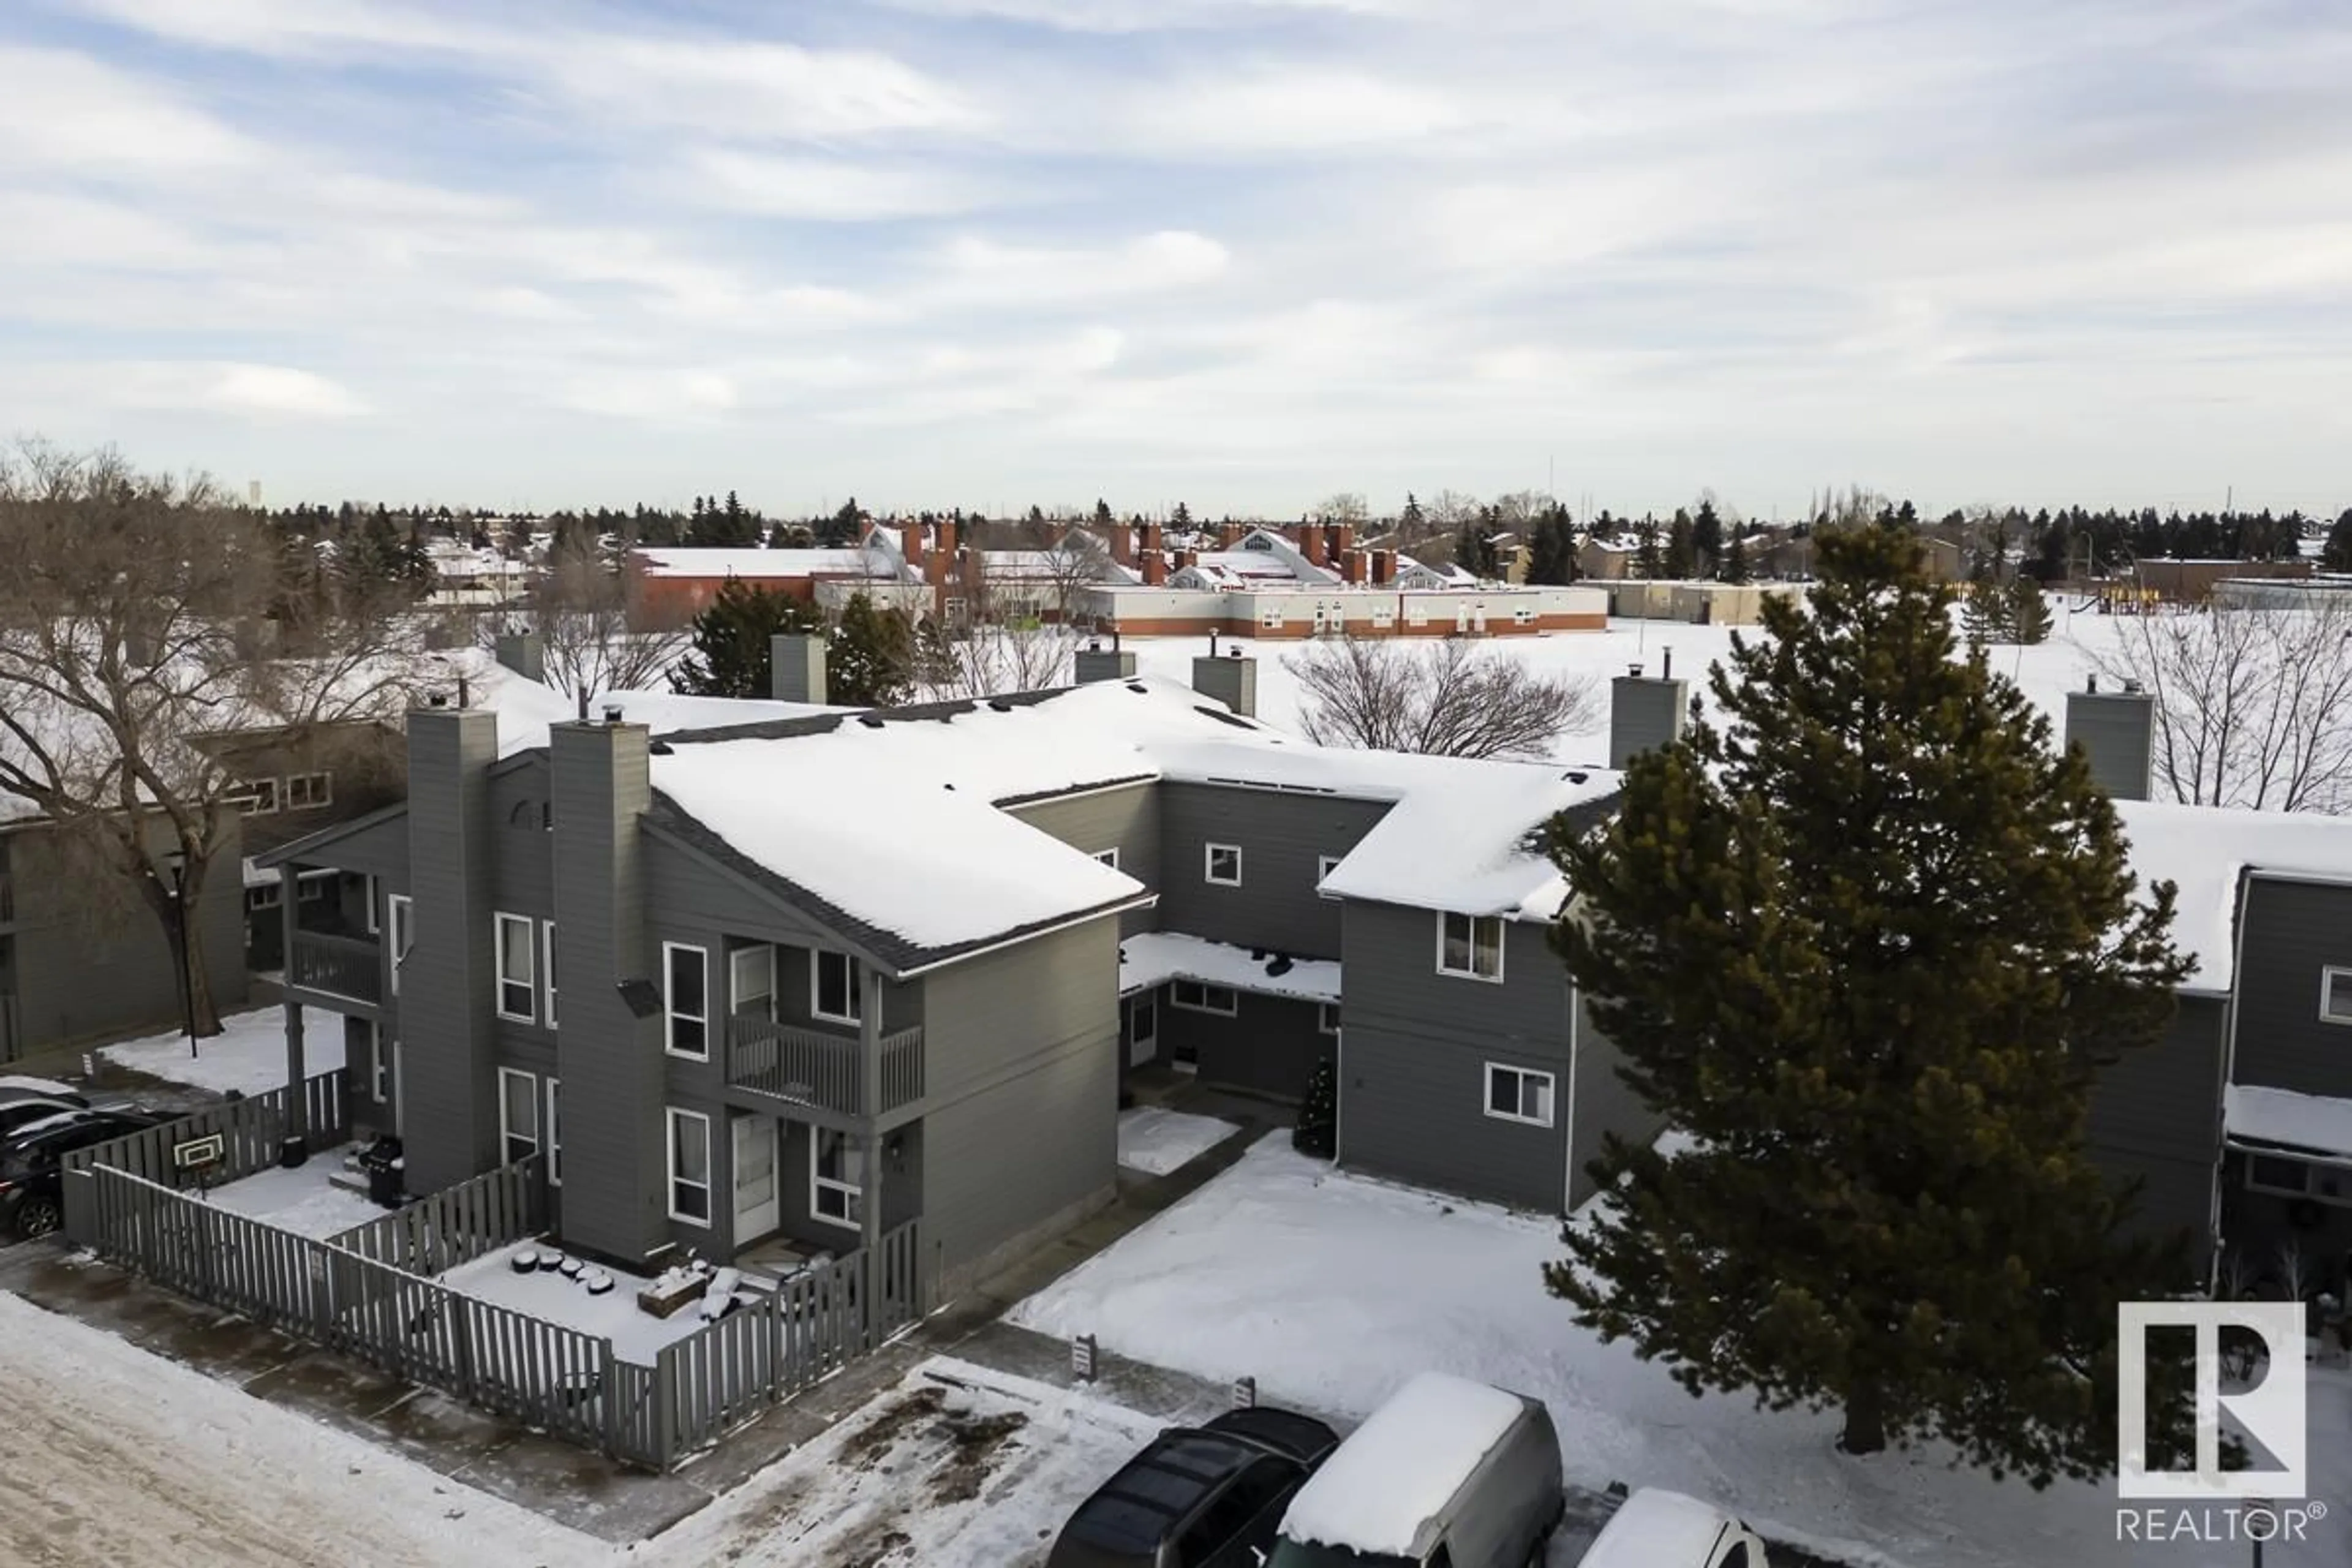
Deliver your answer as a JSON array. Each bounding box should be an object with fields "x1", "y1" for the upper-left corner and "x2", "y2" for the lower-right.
[{"x1": 400, "y1": 705, "x2": 503, "y2": 1194}]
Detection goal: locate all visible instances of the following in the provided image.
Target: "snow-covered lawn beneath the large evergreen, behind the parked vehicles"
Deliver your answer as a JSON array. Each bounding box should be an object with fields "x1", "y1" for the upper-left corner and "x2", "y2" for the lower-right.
[{"x1": 1011, "y1": 1136, "x2": 2352, "y2": 1568}]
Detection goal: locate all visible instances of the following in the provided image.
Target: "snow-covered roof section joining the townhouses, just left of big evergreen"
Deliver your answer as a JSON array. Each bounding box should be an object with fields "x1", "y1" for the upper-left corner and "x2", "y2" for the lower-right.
[{"x1": 1153, "y1": 741, "x2": 1618, "y2": 922}]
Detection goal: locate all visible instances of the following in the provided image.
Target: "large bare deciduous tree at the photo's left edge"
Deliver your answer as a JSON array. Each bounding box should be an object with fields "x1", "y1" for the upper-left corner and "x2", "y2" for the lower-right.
[{"x1": 0, "y1": 442, "x2": 423, "y2": 1035}]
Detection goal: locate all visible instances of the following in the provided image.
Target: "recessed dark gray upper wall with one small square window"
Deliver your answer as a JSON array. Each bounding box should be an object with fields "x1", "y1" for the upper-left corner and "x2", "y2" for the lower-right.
[{"x1": 1157, "y1": 783, "x2": 1388, "y2": 959}]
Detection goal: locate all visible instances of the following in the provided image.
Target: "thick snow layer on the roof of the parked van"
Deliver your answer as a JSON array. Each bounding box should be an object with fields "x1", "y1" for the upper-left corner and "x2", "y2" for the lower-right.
[{"x1": 1282, "y1": 1373, "x2": 1533, "y2": 1568}]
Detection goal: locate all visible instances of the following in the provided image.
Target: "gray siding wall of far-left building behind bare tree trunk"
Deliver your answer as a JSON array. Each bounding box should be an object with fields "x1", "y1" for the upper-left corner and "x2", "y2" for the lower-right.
[{"x1": 0, "y1": 825, "x2": 244, "y2": 1058}]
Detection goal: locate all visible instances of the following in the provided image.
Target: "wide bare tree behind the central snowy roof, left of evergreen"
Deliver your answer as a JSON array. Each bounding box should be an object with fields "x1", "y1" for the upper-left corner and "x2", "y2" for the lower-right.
[{"x1": 1282, "y1": 637, "x2": 1599, "y2": 757}]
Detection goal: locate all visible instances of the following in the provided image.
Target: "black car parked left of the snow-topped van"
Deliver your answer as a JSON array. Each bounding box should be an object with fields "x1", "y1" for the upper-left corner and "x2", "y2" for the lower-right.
[{"x1": 1047, "y1": 1408, "x2": 1338, "y2": 1568}]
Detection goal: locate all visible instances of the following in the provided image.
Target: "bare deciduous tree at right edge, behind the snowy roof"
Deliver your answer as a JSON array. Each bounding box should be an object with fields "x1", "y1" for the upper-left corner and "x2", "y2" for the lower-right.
[{"x1": 2091, "y1": 595, "x2": 2352, "y2": 813}]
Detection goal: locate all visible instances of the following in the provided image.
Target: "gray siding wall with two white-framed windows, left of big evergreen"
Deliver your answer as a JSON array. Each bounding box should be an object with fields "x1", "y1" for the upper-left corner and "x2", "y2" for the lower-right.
[{"x1": 1338, "y1": 900, "x2": 1569, "y2": 1213}]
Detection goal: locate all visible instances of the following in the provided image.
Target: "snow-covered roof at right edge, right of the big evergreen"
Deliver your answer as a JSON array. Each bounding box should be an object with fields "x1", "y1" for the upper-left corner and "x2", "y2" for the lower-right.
[{"x1": 2114, "y1": 799, "x2": 2352, "y2": 992}]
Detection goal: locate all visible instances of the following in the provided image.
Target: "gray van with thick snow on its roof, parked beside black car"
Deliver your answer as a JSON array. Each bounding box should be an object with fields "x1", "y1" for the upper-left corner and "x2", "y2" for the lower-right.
[{"x1": 1270, "y1": 1373, "x2": 1561, "y2": 1568}]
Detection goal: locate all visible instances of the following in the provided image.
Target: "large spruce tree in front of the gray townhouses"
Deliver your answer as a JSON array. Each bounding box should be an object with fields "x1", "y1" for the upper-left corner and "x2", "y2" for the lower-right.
[{"x1": 1545, "y1": 524, "x2": 2192, "y2": 1486}]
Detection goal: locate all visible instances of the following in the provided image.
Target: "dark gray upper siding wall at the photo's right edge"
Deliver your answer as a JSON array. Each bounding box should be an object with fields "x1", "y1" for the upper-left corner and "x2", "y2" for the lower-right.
[{"x1": 2232, "y1": 877, "x2": 2352, "y2": 1096}]
